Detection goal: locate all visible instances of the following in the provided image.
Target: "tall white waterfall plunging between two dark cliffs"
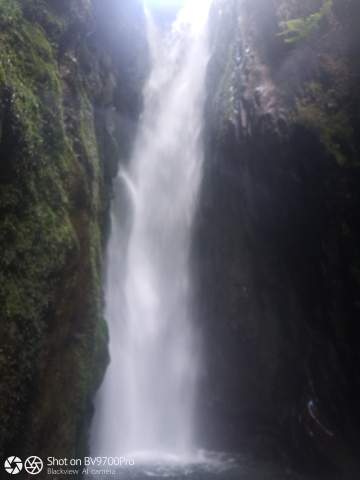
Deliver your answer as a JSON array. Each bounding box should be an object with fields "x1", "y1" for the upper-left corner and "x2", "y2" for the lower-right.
[{"x1": 92, "y1": 0, "x2": 209, "y2": 456}]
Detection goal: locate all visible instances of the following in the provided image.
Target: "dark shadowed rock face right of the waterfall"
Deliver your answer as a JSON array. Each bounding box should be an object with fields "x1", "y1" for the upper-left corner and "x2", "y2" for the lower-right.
[{"x1": 194, "y1": 0, "x2": 360, "y2": 478}]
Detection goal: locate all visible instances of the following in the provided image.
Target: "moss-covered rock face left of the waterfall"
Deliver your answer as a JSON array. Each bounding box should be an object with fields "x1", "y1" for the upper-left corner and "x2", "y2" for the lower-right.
[{"x1": 0, "y1": 0, "x2": 147, "y2": 457}]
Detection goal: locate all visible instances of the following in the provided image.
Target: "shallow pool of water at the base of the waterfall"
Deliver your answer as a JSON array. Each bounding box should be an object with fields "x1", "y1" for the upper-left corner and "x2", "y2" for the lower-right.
[{"x1": 86, "y1": 452, "x2": 320, "y2": 480}]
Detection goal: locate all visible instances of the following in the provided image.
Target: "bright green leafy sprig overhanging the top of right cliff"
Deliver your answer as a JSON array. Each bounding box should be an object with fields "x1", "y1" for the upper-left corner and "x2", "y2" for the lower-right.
[{"x1": 279, "y1": 0, "x2": 333, "y2": 44}]
